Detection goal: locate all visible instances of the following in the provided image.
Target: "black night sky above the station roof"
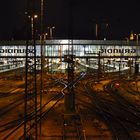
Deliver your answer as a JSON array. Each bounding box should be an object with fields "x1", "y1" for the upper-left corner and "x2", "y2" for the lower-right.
[{"x1": 0, "y1": 0, "x2": 140, "y2": 40}]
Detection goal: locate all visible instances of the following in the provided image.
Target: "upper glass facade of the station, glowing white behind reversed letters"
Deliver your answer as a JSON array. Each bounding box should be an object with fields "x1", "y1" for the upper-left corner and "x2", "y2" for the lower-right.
[{"x1": 0, "y1": 40, "x2": 140, "y2": 57}]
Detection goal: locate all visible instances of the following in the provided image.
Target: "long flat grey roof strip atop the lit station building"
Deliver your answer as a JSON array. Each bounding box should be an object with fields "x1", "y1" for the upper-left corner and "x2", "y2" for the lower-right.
[{"x1": 0, "y1": 39, "x2": 140, "y2": 46}]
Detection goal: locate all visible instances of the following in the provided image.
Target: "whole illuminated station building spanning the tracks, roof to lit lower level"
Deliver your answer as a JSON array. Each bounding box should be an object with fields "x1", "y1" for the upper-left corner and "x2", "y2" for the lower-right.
[{"x1": 0, "y1": 40, "x2": 140, "y2": 73}]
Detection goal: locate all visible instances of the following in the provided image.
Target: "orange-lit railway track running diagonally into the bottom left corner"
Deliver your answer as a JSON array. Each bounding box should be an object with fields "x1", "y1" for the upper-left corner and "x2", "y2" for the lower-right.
[{"x1": 1, "y1": 93, "x2": 64, "y2": 140}]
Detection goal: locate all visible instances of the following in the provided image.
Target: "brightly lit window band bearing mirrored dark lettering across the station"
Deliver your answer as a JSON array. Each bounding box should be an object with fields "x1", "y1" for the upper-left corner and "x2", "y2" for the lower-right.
[{"x1": 0, "y1": 44, "x2": 139, "y2": 56}]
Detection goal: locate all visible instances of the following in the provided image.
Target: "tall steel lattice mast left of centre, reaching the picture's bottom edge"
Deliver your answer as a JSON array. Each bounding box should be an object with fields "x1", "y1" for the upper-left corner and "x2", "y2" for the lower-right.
[{"x1": 24, "y1": 1, "x2": 38, "y2": 140}]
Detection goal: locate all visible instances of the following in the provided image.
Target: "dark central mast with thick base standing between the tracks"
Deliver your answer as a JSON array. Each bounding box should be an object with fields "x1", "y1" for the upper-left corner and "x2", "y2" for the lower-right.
[{"x1": 64, "y1": 0, "x2": 75, "y2": 113}]
